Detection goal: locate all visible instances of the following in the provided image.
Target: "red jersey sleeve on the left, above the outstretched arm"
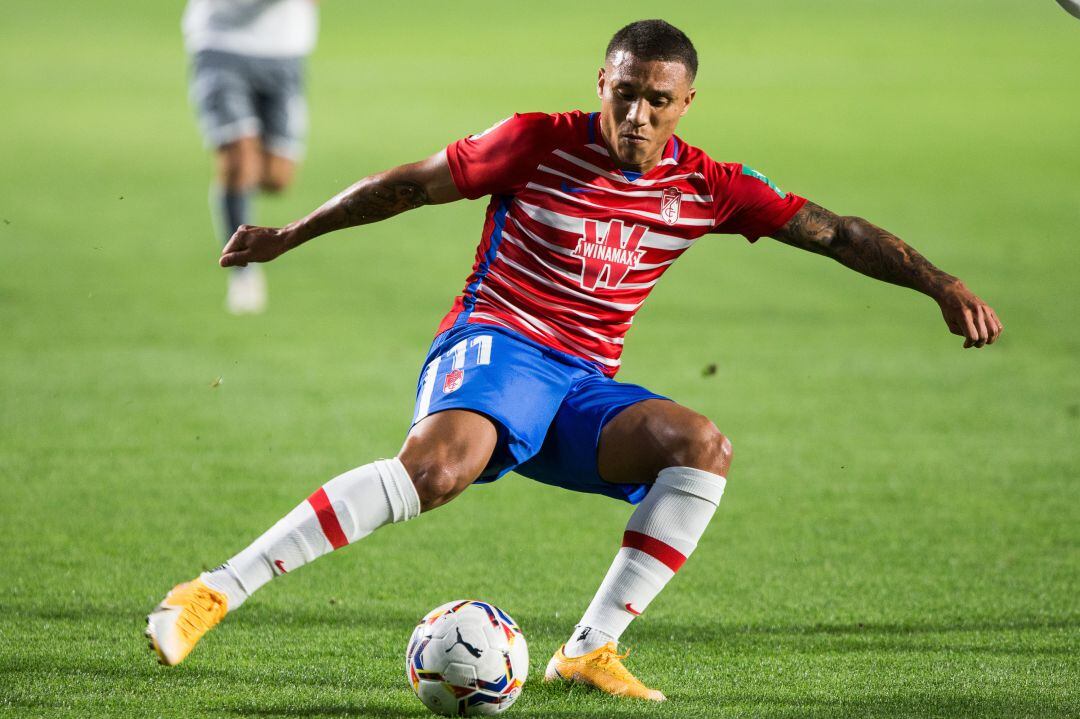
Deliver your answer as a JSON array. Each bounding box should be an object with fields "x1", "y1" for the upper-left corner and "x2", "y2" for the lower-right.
[{"x1": 446, "y1": 112, "x2": 566, "y2": 200}]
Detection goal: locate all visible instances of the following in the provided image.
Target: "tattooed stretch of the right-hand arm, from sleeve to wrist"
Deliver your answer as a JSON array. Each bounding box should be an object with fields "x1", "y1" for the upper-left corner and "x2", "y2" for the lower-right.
[{"x1": 773, "y1": 202, "x2": 959, "y2": 298}]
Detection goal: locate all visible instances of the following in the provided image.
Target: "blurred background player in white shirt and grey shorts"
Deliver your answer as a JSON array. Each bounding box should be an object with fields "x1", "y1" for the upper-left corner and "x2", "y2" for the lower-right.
[{"x1": 183, "y1": 0, "x2": 318, "y2": 314}]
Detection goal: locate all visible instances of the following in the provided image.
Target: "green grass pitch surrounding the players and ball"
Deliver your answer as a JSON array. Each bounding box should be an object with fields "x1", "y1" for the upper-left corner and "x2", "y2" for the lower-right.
[{"x1": 0, "y1": 0, "x2": 1080, "y2": 719}]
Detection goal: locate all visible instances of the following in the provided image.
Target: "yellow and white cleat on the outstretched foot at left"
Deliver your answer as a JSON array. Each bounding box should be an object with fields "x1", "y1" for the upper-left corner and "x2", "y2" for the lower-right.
[{"x1": 146, "y1": 579, "x2": 229, "y2": 666}]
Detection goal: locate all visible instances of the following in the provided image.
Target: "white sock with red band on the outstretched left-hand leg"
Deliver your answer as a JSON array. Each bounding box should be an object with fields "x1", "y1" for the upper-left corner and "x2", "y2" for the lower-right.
[{"x1": 200, "y1": 458, "x2": 420, "y2": 611}]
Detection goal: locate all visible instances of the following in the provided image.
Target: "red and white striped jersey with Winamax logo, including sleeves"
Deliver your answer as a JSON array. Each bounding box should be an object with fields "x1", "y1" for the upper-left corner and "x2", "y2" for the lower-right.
[{"x1": 440, "y1": 111, "x2": 806, "y2": 377}]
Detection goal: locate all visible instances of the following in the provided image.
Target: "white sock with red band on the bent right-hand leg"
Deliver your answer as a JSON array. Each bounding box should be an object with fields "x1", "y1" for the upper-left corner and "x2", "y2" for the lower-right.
[{"x1": 564, "y1": 466, "x2": 727, "y2": 656}]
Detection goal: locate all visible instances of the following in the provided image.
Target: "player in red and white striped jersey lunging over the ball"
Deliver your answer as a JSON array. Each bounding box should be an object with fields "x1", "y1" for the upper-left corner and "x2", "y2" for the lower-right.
[{"x1": 147, "y1": 21, "x2": 1002, "y2": 701}]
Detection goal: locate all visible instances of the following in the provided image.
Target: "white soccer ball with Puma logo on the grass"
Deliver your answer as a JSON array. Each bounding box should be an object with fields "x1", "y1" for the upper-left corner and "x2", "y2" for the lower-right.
[{"x1": 405, "y1": 599, "x2": 529, "y2": 717}]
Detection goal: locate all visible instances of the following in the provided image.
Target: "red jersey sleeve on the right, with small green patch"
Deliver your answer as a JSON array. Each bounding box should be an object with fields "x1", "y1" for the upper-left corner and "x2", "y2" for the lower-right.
[{"x1": 712, "y1": 164, "x2": 806, "y2": 242}]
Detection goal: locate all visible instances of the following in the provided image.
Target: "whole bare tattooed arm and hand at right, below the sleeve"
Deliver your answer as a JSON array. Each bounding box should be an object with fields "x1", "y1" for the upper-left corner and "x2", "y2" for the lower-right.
[{"x1": 771, "y1": 202, "x2": 1003, "y2": 348}]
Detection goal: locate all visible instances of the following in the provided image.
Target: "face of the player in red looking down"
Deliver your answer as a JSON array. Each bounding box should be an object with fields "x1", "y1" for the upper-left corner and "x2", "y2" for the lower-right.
[{"x1": 596, "y1": 51, "x2": 694, "y2": 172}]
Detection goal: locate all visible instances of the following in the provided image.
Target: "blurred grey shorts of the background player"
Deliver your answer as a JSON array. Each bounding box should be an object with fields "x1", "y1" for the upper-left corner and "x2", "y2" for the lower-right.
[{"x1": 190, "y1": 50, "x2": 308, "y2": 160}]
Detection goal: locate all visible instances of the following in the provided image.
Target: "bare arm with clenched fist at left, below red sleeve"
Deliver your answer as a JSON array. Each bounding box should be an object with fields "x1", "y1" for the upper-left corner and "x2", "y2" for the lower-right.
[{"x1": 219, "y1": 150, "x2": 463, "y2": 267}]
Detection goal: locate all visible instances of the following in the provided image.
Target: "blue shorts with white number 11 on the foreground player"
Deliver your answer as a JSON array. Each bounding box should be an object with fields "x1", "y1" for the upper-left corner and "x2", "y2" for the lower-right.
[{"x1": 413, "y1": 324, "x2": 666, "y2": 504}]
